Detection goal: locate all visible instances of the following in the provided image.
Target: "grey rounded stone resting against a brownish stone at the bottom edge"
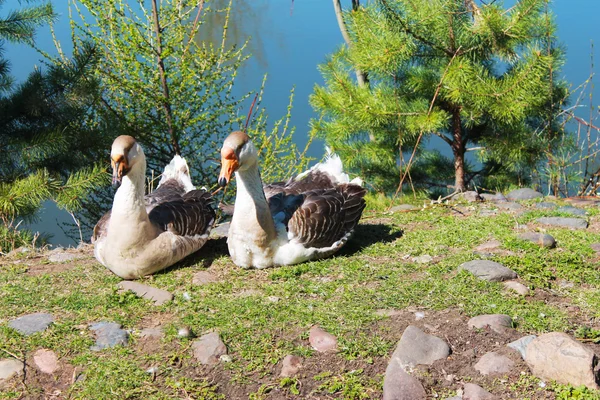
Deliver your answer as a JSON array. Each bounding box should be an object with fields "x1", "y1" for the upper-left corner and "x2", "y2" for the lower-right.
[{"x1": 392, "y1": 325, "x2": 450, "y2": 368}]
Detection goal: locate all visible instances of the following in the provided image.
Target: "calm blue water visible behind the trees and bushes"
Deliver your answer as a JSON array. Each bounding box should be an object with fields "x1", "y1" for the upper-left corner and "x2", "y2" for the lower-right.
[{"x1": 0, "y1": 0, "x2": 600, "y2": 245}]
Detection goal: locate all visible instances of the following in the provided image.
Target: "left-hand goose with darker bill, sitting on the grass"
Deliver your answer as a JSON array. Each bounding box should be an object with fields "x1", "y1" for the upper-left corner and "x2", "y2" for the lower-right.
[{"x1": 92, "y1": 135, "x2": 215, "y2": 279}]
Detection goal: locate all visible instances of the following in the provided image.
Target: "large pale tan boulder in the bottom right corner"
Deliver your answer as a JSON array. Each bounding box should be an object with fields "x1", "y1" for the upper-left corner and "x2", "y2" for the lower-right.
[{"x1": 525, "y1": 332, "x2": 598, "y2": 389}]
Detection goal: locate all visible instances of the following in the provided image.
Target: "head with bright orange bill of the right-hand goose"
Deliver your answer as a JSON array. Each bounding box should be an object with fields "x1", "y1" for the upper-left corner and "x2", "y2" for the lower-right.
[{"x1": 219, "y1": 131, "x2": 258, "y2": 187}]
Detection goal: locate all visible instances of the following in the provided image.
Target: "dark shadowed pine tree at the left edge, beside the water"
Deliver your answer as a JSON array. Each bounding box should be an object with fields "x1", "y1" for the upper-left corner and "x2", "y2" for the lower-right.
[{"x1": 0, "y1": 3, "x2": 107, "y2": 252}]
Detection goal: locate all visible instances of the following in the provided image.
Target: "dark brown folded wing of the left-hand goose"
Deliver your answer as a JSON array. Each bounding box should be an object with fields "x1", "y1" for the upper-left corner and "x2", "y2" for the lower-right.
[{"x1": 148, "y1": 190, "x2": 215, "y2": 237}]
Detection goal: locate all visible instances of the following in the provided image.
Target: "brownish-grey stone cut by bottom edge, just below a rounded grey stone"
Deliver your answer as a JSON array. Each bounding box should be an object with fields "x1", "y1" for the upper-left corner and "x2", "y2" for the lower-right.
[{"x1": 383, "y1": 358, "x2": 427, "y2": 400}]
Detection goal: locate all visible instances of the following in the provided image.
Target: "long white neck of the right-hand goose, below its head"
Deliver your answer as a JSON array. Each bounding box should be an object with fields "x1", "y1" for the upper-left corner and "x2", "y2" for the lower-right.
[{"x1": 231, "y1": 163, "x2": 277, "y2": 241}]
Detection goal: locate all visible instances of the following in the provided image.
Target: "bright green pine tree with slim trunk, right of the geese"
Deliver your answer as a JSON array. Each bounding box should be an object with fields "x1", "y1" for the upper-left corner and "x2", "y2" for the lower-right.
[{"x1": 310, "y1": 0, "x2": 566, "y2": 191}]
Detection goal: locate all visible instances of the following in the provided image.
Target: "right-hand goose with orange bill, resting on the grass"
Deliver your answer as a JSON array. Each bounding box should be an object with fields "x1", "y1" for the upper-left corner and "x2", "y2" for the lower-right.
[{"x1": 218, "y1": 131, "x2": 366, "y2": 269}]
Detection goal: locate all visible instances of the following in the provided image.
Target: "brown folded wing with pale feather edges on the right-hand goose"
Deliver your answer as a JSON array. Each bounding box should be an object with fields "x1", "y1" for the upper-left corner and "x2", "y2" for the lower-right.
[{"x1": 287, "y1": 184, "x2": 367, "y2": 248}]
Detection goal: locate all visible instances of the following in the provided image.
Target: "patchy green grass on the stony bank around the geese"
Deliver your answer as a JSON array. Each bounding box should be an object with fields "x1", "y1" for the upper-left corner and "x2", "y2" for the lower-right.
[{"x1": 0, "y1": 198, "x2": 600, "y2": 399}]
